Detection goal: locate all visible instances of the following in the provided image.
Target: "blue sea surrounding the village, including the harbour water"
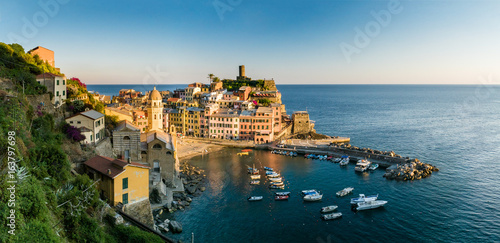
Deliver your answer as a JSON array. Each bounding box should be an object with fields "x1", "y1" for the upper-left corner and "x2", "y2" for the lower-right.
[{"x1": 88, "y1": 85, "x2": 500, "y2": 243}]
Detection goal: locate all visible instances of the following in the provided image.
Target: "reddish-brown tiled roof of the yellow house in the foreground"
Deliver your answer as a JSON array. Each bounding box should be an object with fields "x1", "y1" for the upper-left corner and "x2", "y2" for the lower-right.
[{"x1": 84, "y1": 155, "x2": 150, "y2": 179}]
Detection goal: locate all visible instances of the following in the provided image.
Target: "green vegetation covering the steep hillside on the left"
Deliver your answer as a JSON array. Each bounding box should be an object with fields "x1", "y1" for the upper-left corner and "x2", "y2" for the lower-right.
[{"x1": 0, "y1": 43, "x2": 161, "y2": 242}]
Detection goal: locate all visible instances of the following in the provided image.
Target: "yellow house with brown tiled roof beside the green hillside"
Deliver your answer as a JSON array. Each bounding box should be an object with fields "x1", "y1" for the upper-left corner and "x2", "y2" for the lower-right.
[{"x1": 85, "y1": 156, "x2": 150, "y2": 206}]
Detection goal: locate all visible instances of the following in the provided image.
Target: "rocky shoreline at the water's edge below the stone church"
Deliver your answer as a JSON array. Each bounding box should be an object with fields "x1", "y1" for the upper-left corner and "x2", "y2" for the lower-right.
[{"x1": 155, "y1": 162, "x2": 207, "y2": 234}]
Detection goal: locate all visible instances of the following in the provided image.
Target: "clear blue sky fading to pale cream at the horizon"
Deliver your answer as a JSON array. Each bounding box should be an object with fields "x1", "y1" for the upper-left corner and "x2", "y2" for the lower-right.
[{"x1": 0, "y1": 0, "x2": 500, "y2": 84}]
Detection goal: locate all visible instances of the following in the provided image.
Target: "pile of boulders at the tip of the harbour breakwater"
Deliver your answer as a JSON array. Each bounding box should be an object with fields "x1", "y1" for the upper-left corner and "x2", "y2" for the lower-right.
[{"x1": 384, "y1": 159, "x2": 439, "y2": 181}]
